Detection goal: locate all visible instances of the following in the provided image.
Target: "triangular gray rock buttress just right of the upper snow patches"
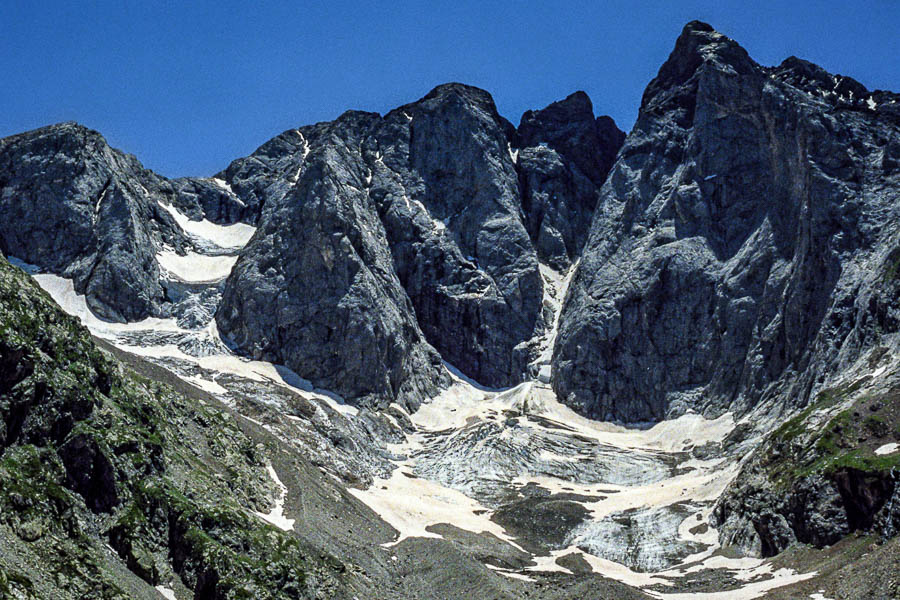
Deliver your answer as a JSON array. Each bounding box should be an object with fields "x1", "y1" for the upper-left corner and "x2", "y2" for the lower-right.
[{"x1": 216, "y1": 113, "x2": 445, "y2": 409}]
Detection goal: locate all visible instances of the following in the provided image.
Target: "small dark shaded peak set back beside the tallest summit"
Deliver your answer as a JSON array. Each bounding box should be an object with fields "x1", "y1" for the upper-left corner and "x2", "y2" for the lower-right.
[{"x1": 516, "y1": 92, "x2": 625, "y2": 269}]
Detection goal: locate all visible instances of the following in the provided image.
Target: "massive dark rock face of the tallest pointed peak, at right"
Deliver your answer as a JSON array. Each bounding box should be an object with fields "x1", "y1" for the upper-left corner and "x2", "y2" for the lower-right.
[{"x1": 553, "y1": 22, "x2": 900, "y2": 421}]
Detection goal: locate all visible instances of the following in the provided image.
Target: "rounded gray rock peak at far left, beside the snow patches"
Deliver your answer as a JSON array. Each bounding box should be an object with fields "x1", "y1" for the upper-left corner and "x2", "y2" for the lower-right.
[{"x1": 0, "y1": 123, "x2": 186, "y2": 321}]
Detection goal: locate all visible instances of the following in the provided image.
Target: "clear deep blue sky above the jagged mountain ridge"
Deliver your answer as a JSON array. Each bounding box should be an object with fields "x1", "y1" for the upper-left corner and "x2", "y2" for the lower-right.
[{"x1": 0, "y1": 0, "x2": 900, "y2": 176}]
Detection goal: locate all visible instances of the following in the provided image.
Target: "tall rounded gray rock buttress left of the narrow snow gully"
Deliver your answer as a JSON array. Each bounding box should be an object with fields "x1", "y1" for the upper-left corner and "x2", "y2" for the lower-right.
[{"x1": 370, "y1": 84, "x2": 542, "y2": 387}]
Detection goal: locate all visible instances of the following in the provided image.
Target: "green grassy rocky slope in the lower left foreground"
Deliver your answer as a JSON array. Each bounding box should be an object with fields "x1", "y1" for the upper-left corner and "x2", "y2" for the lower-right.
[{"x1": 0, "y1": 258, "x2": 342, "y2": 600}]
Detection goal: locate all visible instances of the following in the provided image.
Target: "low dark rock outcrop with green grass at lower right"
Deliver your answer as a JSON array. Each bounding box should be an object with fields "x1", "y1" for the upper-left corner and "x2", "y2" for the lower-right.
[{"x1": 713, "y1": 370, "x2": 900, "y2": 557}]
